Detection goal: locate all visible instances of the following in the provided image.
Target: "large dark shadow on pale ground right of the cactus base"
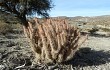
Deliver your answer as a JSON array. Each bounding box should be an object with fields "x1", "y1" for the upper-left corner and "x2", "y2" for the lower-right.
[{"x1": 64, "y1": 48, "x2": 110, "y2": 67}]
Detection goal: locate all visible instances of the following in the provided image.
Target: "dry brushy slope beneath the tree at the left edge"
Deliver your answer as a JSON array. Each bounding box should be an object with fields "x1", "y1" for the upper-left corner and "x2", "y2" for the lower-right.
[{"x1": 0, "y1": 11, "x2": 23, "y2": 34}]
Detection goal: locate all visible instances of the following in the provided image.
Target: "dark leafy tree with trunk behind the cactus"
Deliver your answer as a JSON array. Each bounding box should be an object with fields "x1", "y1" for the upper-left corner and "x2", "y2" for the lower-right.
[{"x1": 0, "y1": 0, "x2": 53, "y2": 27}]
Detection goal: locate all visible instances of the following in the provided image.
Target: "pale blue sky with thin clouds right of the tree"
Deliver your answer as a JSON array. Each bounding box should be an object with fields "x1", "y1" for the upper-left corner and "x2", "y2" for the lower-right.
[{"x1": 49, "y1": 0, "x2": 110, "y2": 17}]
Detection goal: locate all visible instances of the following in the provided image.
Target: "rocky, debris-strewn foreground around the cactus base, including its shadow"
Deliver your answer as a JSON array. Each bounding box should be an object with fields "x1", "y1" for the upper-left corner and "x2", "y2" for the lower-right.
[{"x1": 0, "y1": 30, "x2": 110, "y2": 70}]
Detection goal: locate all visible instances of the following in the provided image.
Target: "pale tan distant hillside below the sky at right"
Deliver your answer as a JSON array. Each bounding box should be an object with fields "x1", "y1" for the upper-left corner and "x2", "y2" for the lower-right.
[{"x1": 73, "y1": 15, "x2": 110, "y2": 25}]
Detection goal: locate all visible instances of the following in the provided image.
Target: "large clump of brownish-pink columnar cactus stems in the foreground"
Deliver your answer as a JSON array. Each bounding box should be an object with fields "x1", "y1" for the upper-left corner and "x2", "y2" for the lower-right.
[{"x1": 24, "y1": 19, "x2": 86, "y2": 63}]
